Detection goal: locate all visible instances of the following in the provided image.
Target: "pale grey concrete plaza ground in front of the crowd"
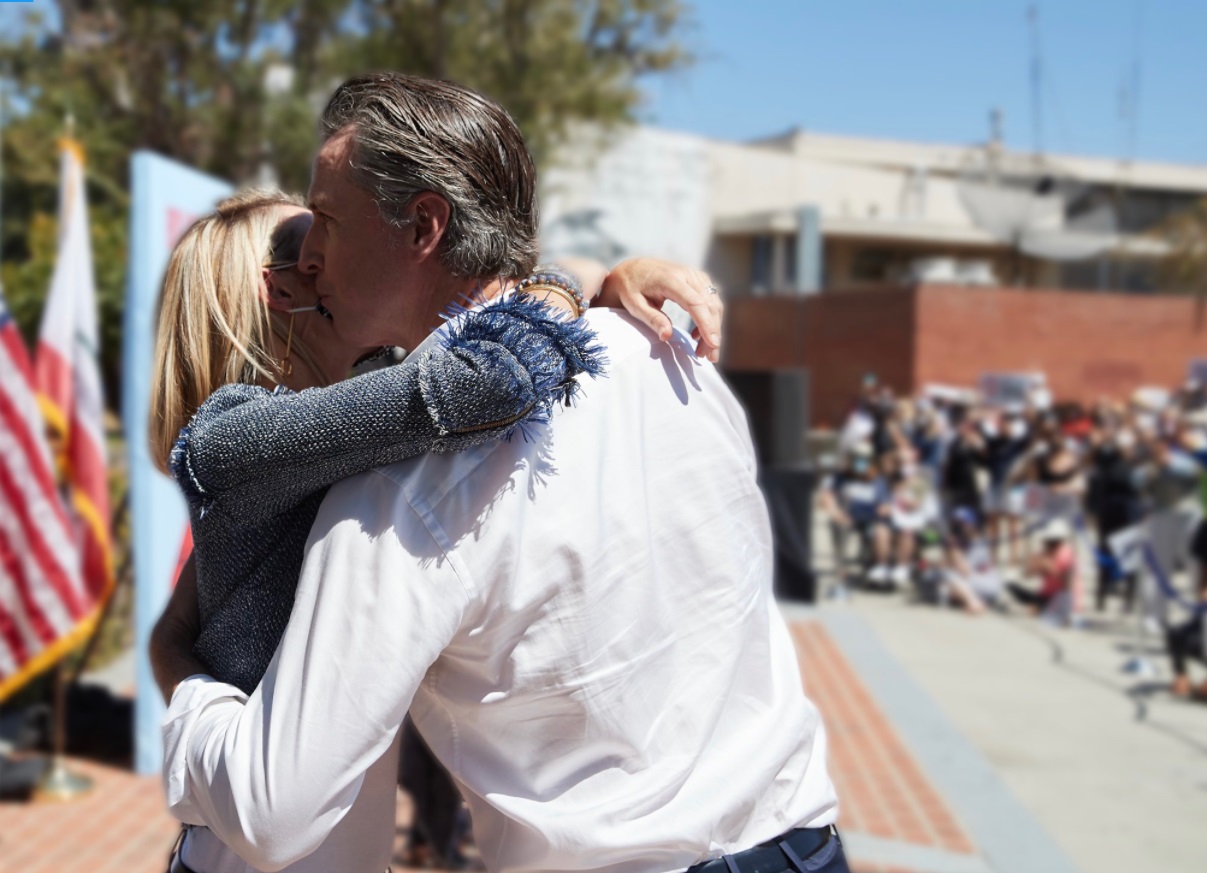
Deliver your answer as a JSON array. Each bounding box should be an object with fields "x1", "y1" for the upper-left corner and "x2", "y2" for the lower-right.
[{"x1": 806, "y1": 594, "x2": 1207, "y2": 873}]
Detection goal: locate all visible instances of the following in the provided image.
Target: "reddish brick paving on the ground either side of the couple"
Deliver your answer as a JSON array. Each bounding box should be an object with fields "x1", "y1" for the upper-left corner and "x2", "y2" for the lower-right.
[{"x1": 0, "y1": 621, "x2": 989, "y2": 873}]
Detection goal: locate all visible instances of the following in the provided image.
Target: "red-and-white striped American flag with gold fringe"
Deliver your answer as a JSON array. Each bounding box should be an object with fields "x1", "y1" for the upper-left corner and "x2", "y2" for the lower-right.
[{"x1": 0, "y1": 292, "x2": 95, "y2": 700}]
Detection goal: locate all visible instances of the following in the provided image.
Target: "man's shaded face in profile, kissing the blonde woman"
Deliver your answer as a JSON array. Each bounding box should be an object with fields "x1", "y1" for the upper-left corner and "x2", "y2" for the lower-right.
[{"x1": 299, "y1": 133, "x2": 415, "y2": 348}]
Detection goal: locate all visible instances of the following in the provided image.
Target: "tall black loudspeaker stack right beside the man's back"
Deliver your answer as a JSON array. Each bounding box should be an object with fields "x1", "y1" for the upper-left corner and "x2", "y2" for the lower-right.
[{"x1": 725, "y1": 369, "x2": 816, "y2": 603}]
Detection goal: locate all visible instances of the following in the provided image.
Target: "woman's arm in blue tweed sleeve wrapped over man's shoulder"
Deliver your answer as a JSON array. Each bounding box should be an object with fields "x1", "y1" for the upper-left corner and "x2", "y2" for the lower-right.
[{"x1": 170, "y1": 296, "x2": 602, "y2": 526}]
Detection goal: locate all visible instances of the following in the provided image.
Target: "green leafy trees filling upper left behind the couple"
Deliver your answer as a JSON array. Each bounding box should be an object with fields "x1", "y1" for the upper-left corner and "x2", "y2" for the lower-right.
[{"x1": 0, "y1": 0, "x2": 690, "y2": 403}]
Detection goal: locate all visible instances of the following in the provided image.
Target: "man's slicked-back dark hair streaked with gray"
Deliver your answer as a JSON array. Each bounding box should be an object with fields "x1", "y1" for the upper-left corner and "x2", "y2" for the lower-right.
[{"x1": 320, "y1": 72, "x2": 540, "y2": 279}]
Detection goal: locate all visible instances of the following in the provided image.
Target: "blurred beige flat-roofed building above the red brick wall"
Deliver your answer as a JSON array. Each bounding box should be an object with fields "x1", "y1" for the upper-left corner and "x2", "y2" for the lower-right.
[{"x1": 543, "y1": 127, "x2": 1207, "y2": 297}]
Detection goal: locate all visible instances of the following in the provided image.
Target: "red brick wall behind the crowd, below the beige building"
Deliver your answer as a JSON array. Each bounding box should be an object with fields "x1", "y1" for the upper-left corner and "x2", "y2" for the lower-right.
[{"x1": 724, "y1": 285, "x2": 1207, "y2": 426}]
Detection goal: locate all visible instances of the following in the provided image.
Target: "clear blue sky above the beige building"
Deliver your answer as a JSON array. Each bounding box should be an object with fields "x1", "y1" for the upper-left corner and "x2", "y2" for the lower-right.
[{"x1": 642, "y1": 0, "x2": 1207, "y2": 164}]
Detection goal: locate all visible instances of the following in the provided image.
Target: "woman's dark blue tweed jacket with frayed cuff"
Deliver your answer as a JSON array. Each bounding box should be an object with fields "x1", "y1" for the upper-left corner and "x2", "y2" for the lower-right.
[{"x1": 170, "y1": 296, "x2": 604, "y2": 693}]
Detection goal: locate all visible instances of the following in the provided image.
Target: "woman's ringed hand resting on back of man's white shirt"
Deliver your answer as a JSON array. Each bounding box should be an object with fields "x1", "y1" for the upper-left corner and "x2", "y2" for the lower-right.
[{"x1": 596, "y1": 257, "x2": 724, "y2": 363}]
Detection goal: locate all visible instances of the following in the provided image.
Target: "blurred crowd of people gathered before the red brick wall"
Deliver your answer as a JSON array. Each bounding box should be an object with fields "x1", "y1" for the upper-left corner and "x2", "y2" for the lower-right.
[{"x1": 820, "y1": 377, "x2": 1207, "y2": 697}]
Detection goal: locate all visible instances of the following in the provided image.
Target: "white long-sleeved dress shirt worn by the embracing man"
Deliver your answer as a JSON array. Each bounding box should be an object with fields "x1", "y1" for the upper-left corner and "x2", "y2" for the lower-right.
[{"x1": 164, "y1": 309, "x2": 836, "y2": 873}]
